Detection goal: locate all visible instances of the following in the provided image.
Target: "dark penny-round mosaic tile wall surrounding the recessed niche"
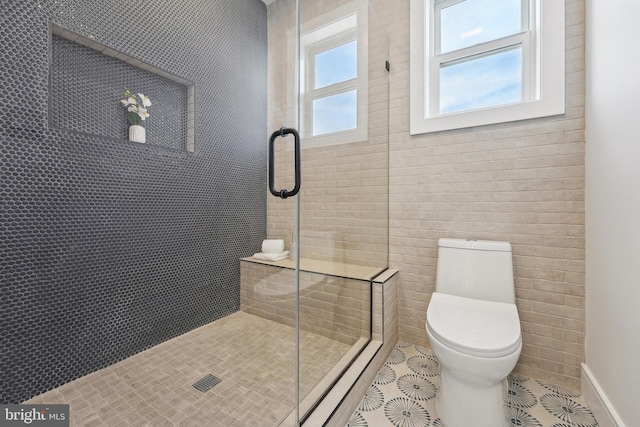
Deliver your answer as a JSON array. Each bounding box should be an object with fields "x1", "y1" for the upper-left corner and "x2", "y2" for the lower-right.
[{"x1": 0, "y1": 0, "x2": 267, "y2": 403}]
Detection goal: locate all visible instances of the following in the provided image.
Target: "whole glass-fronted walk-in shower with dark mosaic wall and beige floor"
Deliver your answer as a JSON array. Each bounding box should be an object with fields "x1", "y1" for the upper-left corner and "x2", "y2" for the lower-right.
[{"x1": 0, "y1": 0, "x2": 389, "y2": 426}]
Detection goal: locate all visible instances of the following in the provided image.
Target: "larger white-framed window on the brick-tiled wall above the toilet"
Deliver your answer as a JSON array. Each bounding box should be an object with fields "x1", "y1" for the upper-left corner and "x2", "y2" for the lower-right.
[{"x1": 410, "y1": 0, "x2": 565, "y2": 134}]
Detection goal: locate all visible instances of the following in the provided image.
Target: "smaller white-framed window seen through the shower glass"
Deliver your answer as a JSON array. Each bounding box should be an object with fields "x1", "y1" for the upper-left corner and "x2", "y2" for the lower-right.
[{"x1": 300, "y1": 3, "x2": 367, "y2": 145}]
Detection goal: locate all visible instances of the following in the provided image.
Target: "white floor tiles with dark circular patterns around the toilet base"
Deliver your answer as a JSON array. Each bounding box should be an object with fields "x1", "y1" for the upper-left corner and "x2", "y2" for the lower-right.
[{"x1": 347, "y1": 343, "x2": 598, "y2": 427}]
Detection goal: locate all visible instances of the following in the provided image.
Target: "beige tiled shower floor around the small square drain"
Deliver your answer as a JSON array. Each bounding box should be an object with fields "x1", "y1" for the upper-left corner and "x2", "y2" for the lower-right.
[{"x1": 28, "y1": 312, "x2": 350, "y2": 427}]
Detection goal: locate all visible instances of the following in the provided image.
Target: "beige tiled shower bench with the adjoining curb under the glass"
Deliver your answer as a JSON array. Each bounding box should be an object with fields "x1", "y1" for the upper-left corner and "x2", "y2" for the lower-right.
[{"x1": 240, "y1": 257, "x2": 398, "y2": 426}]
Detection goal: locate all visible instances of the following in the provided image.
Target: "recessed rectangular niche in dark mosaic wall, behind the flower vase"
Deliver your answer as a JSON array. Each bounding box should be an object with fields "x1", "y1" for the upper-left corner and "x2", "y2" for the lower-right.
[{"x1": 49, "y1": 23, "x2": 195, "y2": 152}]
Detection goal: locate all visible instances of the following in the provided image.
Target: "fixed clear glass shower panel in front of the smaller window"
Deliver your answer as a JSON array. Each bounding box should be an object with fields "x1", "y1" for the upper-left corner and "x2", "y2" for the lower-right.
[{"x1": 296, "y1": 0, "x2": 389, "y2": 420}]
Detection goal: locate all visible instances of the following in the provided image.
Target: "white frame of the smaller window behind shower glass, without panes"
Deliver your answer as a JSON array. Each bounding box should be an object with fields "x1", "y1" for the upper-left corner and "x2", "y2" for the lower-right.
[{"x1": 300, "y1": 2, "x2": 369, "y2": 146}]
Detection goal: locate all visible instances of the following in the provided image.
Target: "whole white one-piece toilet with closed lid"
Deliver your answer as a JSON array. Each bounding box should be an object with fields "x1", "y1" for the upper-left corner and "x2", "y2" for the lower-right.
[{"x1": 426, "y1": 239, "x2": 522, "y2": 427}]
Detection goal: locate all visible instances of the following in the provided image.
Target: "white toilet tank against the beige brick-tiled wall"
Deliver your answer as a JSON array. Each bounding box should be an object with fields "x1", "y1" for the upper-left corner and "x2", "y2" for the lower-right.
[{"x1": 436, "y1": 239, "x2": 515, "y2": 304}]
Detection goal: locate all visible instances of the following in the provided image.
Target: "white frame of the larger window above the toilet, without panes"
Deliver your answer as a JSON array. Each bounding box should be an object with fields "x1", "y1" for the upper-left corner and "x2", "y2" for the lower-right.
[{"x1": 410, "y1": 0, "x2": 565, "y2": 135}]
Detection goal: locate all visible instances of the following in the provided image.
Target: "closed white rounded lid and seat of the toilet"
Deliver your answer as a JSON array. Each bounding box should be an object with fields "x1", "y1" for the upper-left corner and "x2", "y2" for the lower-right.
[{"x1": 427, "y1": 292, "x2": 521, "y2": 357}]
